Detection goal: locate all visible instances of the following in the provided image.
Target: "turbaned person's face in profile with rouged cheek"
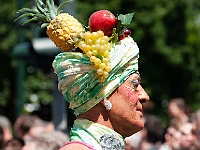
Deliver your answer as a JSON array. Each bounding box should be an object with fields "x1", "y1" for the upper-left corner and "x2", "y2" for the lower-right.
[{"x1": 108, "y1": 73, "x2": 149, "y2": 137}]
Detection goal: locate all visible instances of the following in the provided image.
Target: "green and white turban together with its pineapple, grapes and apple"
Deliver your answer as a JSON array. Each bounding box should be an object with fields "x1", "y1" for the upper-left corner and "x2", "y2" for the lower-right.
[{"x1": 16, "y1": 0, "x2": 139, "y2": 116}]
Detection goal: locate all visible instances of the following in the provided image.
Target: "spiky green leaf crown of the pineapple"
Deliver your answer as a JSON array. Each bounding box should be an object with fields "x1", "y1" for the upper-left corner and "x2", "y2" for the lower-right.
[{"x1": 15, "y1": 0, "x2": 72, "y2": 27}]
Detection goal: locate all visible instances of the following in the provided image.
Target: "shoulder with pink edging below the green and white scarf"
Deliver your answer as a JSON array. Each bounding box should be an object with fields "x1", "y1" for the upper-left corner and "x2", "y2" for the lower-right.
[{"x1": 59, "y1": 141, "x2": 94, "y2": 150}]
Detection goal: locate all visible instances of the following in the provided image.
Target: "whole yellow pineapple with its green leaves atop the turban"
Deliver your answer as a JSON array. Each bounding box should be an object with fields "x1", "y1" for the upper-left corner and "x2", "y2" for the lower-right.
[{"x1": 16, "y1": 0, "x2": 85, "y2": 52}]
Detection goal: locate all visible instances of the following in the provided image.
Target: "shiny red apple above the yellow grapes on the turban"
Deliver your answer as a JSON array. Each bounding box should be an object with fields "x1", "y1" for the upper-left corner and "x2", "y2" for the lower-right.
[{"x1": 89, "y1": 10, "x2": 117, "y2": 36}]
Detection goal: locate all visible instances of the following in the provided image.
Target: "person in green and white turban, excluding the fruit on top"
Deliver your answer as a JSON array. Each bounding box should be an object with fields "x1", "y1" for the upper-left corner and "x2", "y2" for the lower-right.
[{"x1": 53, "y1": 28, "x2": 149, "y2": 150}]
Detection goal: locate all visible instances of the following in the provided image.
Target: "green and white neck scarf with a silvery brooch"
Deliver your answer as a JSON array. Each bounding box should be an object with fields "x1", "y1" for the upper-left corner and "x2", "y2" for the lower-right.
[{"x1": 70, "y1": 119, "x2": 126, "y2": 150}]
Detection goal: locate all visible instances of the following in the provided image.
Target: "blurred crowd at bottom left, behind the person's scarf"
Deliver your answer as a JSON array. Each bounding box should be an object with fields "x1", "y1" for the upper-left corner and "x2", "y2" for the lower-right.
[{"x1": 0, "y1": 115, "x2": 69, "y2": 150}]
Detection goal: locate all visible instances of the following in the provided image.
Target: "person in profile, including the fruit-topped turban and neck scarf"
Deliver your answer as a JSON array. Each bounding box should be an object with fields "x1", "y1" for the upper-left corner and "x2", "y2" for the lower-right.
[{"x1": 16, "y1": 0, "x2": 149, "y2": 150}]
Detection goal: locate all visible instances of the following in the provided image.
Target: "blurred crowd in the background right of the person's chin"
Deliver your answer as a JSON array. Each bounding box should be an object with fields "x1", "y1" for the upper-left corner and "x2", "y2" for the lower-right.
[{"x1": 126, "y1": 98, "x2": 200, "y2": 150}]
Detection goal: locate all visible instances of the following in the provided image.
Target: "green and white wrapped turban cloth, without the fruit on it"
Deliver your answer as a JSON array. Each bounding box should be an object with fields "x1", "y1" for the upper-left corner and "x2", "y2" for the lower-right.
[{"x1": 53, "y1": 37, "x2": 139, "y2": 116}]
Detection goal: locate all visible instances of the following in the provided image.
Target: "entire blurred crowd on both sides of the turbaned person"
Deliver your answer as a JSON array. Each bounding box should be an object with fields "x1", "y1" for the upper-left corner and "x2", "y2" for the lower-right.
[{"x1": 0, "y1": 98, "x2": 200, "y2": 150}]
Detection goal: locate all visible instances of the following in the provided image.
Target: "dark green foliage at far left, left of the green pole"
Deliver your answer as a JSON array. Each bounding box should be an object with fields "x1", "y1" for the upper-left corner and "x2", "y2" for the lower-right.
[{"x1": 0, "y1": 0, "x2": 17, "y2": 107}]
